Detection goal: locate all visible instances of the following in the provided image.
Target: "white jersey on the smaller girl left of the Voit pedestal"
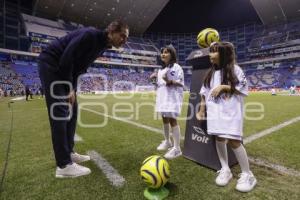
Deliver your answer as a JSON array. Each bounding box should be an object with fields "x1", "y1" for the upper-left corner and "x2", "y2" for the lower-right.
[{"x1": 155, "y1": 63, "x2": 184, "y2": 114}]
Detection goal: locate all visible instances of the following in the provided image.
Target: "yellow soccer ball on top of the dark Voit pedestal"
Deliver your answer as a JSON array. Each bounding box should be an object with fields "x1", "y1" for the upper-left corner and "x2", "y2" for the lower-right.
[{"x1": 197, "y1": 28, "x2": 220, "y2": 48}]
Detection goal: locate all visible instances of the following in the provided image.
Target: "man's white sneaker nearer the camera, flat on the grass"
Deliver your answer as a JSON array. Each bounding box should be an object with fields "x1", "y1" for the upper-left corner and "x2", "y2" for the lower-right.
[{"x1": 55, "y1": 163, "x2": 91, "y2": 178}]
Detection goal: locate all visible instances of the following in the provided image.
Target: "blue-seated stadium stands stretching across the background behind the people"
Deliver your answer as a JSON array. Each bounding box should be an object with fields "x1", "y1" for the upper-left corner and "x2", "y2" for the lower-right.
[{"x1": 1, "y1": 8, "x2": 300, "y2": 93}]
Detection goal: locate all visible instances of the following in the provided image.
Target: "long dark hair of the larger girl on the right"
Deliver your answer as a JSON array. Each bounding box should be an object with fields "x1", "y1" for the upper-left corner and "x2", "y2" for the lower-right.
[{"x1": 204, "y1": 42, "x2": 238, "y2": 94}]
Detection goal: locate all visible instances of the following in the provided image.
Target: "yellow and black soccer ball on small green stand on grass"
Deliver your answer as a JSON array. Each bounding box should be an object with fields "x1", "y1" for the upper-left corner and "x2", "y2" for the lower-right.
[{"x1": 140, "y1": 155, "x2": 170, "y2": 188}]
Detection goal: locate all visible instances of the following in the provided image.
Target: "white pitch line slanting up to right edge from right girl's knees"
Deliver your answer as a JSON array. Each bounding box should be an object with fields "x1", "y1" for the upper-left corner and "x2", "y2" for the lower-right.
[{"x1": 244, "y1": 116, "x2": 300, "y2": 144}]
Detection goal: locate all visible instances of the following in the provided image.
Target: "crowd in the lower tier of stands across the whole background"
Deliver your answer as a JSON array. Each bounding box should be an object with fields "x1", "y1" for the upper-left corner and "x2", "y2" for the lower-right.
[{"x1": 0, "y1": 59, "x2": 300, "y2": 96}]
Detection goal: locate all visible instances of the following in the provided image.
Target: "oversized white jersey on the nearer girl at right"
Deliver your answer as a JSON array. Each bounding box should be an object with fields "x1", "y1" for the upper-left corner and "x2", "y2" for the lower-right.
[{"x1": 200, "y1": 65, "x2": 248, "y2": 137}]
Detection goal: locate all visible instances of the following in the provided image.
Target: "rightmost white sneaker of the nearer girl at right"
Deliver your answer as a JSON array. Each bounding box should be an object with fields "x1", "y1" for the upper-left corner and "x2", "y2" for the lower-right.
[{"x1": 235, "y1": 172, "x2": 257, "y2": 192}]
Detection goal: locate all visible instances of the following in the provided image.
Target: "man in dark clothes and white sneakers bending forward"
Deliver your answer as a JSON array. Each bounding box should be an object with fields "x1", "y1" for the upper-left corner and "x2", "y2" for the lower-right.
[{"x1": 38, "y1": 21, "x2": 129, "y2": 178}]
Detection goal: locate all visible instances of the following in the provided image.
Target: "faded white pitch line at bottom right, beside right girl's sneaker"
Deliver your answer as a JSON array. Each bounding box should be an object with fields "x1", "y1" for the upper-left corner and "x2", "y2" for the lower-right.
[{"x1": 248, "y1": 156, "x2": 300, "y2": 177}]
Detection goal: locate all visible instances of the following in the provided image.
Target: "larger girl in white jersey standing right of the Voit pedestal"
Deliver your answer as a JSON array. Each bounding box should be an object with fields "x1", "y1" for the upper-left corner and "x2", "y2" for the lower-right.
[{"x1": 197, "y1": 42, "x2": 257, "y2": 192}]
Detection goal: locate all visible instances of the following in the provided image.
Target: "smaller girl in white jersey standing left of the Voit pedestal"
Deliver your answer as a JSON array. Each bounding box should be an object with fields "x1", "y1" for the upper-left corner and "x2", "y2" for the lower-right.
[{"x1": 151, "y1": 45, "x2": 184, "y2": 159}]
